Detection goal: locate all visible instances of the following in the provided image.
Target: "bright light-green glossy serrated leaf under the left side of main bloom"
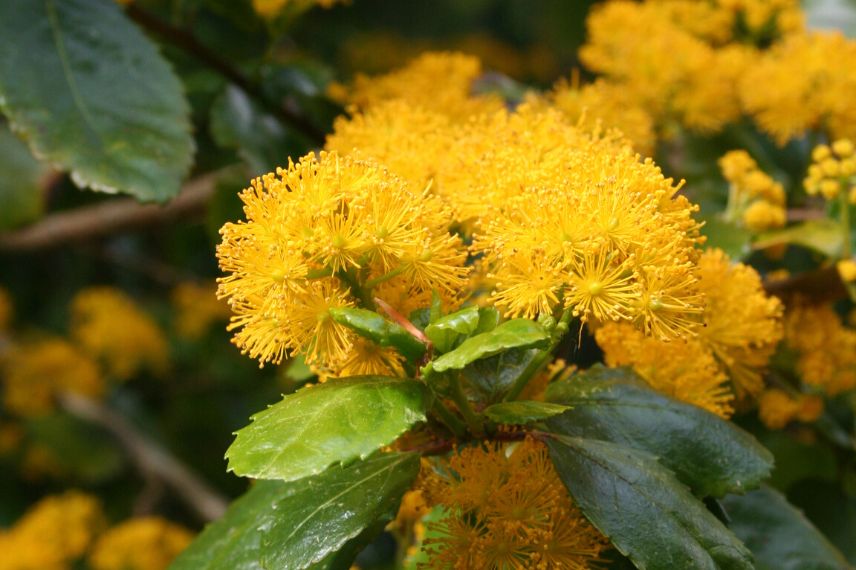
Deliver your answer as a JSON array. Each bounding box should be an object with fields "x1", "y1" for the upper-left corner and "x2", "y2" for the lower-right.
[{"x1": 226, "y1": 376, "x2": 426, "y2": 481}]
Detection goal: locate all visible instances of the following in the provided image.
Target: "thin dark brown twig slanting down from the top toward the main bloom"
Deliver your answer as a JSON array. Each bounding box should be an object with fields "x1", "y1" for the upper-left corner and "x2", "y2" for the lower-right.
[{"x1": 125, "y1": 4, "x2": 325, "y2": 144}]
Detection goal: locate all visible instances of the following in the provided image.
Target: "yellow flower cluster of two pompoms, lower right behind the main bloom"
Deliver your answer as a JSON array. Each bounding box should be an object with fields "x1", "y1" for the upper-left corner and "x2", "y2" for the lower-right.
[{"x1": 595, "y1": 249, "x2": 783, "y2": 404}]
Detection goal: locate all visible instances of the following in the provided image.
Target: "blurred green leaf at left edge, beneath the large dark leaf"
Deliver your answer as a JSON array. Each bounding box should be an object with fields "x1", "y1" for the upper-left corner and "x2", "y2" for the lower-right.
[{"x1": 0, "y1": 122, "x2": 50, "y2": 230}]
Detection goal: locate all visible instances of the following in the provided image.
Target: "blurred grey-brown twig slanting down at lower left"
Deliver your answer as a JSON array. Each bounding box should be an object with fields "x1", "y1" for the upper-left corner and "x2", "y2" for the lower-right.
[{"x1": 59, "y1": 392, "x2": 227, "y2": 522}]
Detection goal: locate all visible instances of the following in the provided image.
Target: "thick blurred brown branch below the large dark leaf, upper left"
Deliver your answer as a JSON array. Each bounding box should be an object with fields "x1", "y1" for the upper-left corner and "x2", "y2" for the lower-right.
[{"x1": 0, "y1": 174, "x2": 215, "y2": 251}]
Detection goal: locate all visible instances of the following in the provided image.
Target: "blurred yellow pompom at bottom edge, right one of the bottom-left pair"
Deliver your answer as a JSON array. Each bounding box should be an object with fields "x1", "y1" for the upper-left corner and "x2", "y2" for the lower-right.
[{"x1": 89, "y1": 517, "x2": 193, "y2": 570}]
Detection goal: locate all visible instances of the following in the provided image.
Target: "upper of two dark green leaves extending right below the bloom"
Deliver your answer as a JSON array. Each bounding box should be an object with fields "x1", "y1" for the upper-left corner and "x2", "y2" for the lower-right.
[{"x1": 546, "y1": 366, "x2": 773, "y2": 497}]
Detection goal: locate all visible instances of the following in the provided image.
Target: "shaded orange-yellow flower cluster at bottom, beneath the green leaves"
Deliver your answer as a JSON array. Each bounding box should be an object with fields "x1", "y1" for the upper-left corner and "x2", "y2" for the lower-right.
[{"x1": 422, "y1": 440, "x2": 607, "y2": 570}]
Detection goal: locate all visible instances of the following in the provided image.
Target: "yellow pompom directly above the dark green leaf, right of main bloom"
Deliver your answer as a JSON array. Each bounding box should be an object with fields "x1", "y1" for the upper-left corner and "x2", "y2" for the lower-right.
[{"x1": 595, "y1": 323, "x2": 734, "y2": 418}]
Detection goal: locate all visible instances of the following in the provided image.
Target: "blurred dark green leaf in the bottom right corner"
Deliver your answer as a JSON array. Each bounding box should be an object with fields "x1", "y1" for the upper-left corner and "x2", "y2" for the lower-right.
[{"x1": 723, "y1": 487, "x2": 848, "y2": 570}]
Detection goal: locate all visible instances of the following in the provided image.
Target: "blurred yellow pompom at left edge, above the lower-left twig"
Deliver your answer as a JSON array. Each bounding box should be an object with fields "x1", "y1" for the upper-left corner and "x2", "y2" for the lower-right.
[{"x1": 2, "y1": 339, "x2": 104, "y2": 416}]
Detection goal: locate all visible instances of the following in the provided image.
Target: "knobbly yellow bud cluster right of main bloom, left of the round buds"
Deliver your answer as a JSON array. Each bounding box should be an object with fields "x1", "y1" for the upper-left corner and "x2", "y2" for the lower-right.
[{"x1": 719, "y1": 150, "x2": 787, "y2": 232}]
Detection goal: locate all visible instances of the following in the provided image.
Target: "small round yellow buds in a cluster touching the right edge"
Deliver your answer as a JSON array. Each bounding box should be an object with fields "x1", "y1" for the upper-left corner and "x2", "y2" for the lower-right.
[{"x1": 803, "y1": 139, "x2": 856, "y2": 204}]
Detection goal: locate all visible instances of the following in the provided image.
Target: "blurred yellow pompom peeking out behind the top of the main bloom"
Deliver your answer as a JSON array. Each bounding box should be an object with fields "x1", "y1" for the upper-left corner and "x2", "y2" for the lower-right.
[{"x1": 350, "y1": 52, "x2": 505, "y2": 120}]
